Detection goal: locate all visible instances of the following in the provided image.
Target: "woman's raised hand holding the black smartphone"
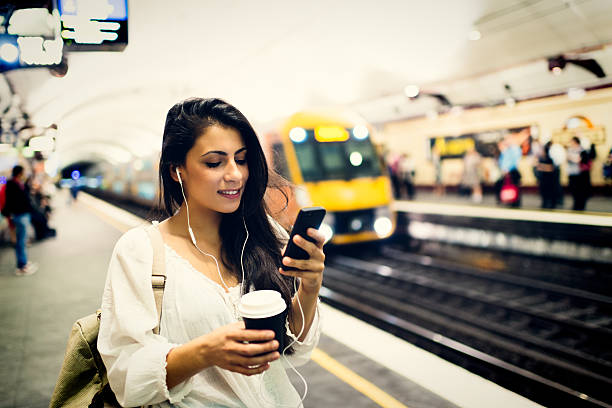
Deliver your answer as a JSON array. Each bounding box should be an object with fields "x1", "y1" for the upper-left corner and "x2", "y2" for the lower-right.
[{"x1": 279, "y1": 228, "x2": 325, "y2": 293}]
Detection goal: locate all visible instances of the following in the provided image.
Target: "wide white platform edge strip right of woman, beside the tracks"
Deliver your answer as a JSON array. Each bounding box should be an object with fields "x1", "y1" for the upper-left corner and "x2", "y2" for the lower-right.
[{"x1": 321, "y1": 304, "x2": 542, "y2": 408}]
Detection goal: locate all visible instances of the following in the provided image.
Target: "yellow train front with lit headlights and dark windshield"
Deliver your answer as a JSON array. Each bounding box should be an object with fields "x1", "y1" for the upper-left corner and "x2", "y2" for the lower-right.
[{"x1": 265, "y1": 110, "x2": 396, "y2": 244}]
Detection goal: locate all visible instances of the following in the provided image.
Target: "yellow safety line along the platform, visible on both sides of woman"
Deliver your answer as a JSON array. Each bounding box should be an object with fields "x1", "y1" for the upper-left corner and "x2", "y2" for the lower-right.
[{"x1": 80, "y1": 194, "x2": 408, "y2": 408}]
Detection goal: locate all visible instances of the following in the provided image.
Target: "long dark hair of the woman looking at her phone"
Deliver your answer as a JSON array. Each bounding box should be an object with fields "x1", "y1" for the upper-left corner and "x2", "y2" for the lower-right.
[{"x1": 159, "y1": 98, "x2": 294, "y2": 342}]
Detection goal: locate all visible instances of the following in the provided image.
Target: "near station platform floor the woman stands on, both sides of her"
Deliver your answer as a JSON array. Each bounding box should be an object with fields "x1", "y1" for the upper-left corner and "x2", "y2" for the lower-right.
[{"x1": 0, "y1": 192, "x2": 540, "y2": 408}]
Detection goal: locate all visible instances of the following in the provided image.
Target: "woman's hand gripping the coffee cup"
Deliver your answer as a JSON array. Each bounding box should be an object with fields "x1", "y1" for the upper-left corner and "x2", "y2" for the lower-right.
[{"x1": 201, "y1": 322, "x2": 280, "y2": 375}]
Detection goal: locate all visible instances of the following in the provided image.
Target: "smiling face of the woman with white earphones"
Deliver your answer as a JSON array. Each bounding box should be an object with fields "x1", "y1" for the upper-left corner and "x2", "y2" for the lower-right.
[{"x1": 179, "y1": 125, "x2": 249, "y2": 213}]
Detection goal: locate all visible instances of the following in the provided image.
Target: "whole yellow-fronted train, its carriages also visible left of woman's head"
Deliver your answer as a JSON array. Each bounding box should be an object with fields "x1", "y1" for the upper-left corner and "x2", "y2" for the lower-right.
[{"x1": 76, "y1": 109, "x2": 397, "y2": 245}]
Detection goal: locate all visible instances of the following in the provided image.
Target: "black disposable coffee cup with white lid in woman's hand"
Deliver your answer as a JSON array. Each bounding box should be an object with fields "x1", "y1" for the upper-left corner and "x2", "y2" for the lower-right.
[{"x1": 238, "y1": 290, "x2": 287, "y2": 351}]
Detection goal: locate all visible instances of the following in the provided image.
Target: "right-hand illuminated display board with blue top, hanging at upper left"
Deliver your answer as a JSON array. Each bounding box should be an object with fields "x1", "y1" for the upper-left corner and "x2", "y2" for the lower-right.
[{"x1": 57, "y1": 0, "x2": 128, "y2": 51}]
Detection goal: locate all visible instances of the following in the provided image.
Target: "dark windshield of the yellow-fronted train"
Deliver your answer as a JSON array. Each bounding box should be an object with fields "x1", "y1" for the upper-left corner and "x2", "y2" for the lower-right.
[{"x1": 293, "y1": 130, "x2": 382, "y2": 181}]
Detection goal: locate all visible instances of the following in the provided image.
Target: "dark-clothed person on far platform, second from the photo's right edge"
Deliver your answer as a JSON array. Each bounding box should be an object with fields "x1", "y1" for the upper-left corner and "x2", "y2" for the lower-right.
[{"x1": 567, "y1": 136, "x2": 591, "y2": 211}]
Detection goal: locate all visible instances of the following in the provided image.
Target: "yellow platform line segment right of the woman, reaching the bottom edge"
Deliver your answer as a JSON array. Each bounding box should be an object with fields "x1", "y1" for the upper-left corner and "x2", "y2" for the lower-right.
[{"x1": 312, "y1": 348, "x2": 408, "y2": 408}]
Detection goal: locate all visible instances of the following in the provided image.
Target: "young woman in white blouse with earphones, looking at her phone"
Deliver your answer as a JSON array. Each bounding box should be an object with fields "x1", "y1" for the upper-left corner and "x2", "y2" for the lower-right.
[{"x1": 98, "y1": 98, "x2": 325, "y2": 408}]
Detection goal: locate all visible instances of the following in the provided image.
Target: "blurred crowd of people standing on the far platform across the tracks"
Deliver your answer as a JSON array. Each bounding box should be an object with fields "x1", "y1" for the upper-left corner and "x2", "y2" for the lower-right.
[{"x1": 385, "y1": 136, "x2": 612, "y2": 211}]
